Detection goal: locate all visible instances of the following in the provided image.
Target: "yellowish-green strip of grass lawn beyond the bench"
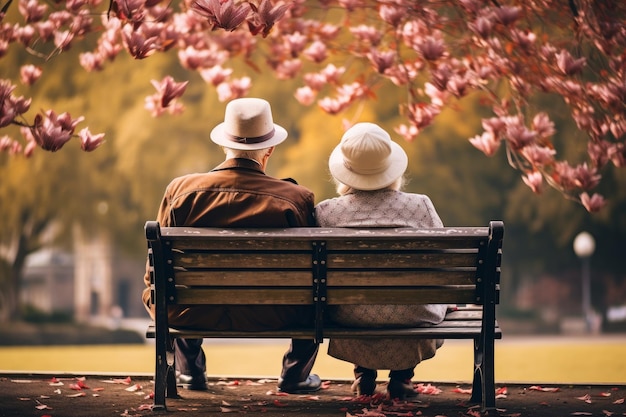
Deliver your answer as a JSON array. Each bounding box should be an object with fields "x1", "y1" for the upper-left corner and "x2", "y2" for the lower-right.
[{"x1": 0, "y1": 335, "x2": 626, "y2": 384}]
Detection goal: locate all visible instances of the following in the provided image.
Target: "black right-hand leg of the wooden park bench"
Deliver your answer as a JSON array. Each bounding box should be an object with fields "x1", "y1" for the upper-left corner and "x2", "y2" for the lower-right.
[{"x1": 470, "y1": 337, "x2": 498, "y2": 416}]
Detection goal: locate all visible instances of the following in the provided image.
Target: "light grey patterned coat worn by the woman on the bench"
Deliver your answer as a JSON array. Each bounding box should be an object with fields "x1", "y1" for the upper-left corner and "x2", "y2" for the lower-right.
[{"x1": 315, "y1": 190, "x2": 448, "y2": 370}]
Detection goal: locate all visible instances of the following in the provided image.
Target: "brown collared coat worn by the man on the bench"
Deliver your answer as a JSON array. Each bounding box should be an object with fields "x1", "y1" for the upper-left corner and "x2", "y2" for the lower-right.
[{"x1": 142, "y1": 158, "x2": 315, "y2": 330}]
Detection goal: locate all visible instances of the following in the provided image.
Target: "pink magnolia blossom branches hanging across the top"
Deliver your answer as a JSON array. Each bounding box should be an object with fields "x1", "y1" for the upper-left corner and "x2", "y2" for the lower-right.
[{"x1": 0, "y1": 0, "x2": 626, "y2": 212}]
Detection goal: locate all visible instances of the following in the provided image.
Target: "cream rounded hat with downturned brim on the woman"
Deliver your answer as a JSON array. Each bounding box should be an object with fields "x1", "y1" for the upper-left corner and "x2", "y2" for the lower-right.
[{"x1": 328, "y1": 123, "x2": 408, "y2": 190}]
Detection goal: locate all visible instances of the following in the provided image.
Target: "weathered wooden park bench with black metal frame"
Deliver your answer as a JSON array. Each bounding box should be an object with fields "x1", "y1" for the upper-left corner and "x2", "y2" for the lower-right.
[{"x1": 145, "y1": 221, "x2": 504, "y2": 411}]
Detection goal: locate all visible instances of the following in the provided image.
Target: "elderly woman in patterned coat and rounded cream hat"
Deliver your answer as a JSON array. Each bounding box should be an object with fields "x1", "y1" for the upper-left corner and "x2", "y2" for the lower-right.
[{"x1": 315, "y1": 123, "x2": 447, "y2": 399}]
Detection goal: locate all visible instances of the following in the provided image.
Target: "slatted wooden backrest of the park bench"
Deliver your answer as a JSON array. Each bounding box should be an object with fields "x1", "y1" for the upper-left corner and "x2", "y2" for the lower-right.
[{"x1": 146, "y1": 221, "x2": 504, "y2": 340}]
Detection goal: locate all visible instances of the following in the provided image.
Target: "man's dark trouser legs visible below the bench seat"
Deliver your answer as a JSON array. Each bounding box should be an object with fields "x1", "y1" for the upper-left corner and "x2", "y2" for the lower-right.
[{"x1": 174, "y1": 338, "x2": 319, "y2": 383}]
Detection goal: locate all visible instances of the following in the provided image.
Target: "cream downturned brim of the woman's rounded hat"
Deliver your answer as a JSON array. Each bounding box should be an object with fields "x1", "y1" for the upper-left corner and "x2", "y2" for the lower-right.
[{"x1": 328, "y1": 141, "x2": 409, "y2": 191}]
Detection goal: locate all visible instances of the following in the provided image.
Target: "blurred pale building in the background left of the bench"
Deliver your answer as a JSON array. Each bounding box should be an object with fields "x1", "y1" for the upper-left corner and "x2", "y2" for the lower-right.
[{"x1": 20, "y1": 245, "x2": 147, "y2": 322}]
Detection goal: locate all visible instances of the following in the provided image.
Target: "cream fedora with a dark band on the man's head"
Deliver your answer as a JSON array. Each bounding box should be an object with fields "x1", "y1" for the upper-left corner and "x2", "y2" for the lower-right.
[{"x1": 211, "y1": 98, "x2": 287, "y2": 150}]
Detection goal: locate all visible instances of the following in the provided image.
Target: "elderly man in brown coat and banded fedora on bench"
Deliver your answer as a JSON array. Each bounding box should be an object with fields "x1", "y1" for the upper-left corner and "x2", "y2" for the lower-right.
[{"x1": 143, "y1": 98, "x2": 321, "y2": 393}]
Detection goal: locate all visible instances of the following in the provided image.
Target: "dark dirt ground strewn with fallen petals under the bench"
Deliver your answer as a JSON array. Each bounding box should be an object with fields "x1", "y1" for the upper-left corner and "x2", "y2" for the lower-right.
[{"x1": 0, "y1": 374, "x2": 626, "y2": 417}]
